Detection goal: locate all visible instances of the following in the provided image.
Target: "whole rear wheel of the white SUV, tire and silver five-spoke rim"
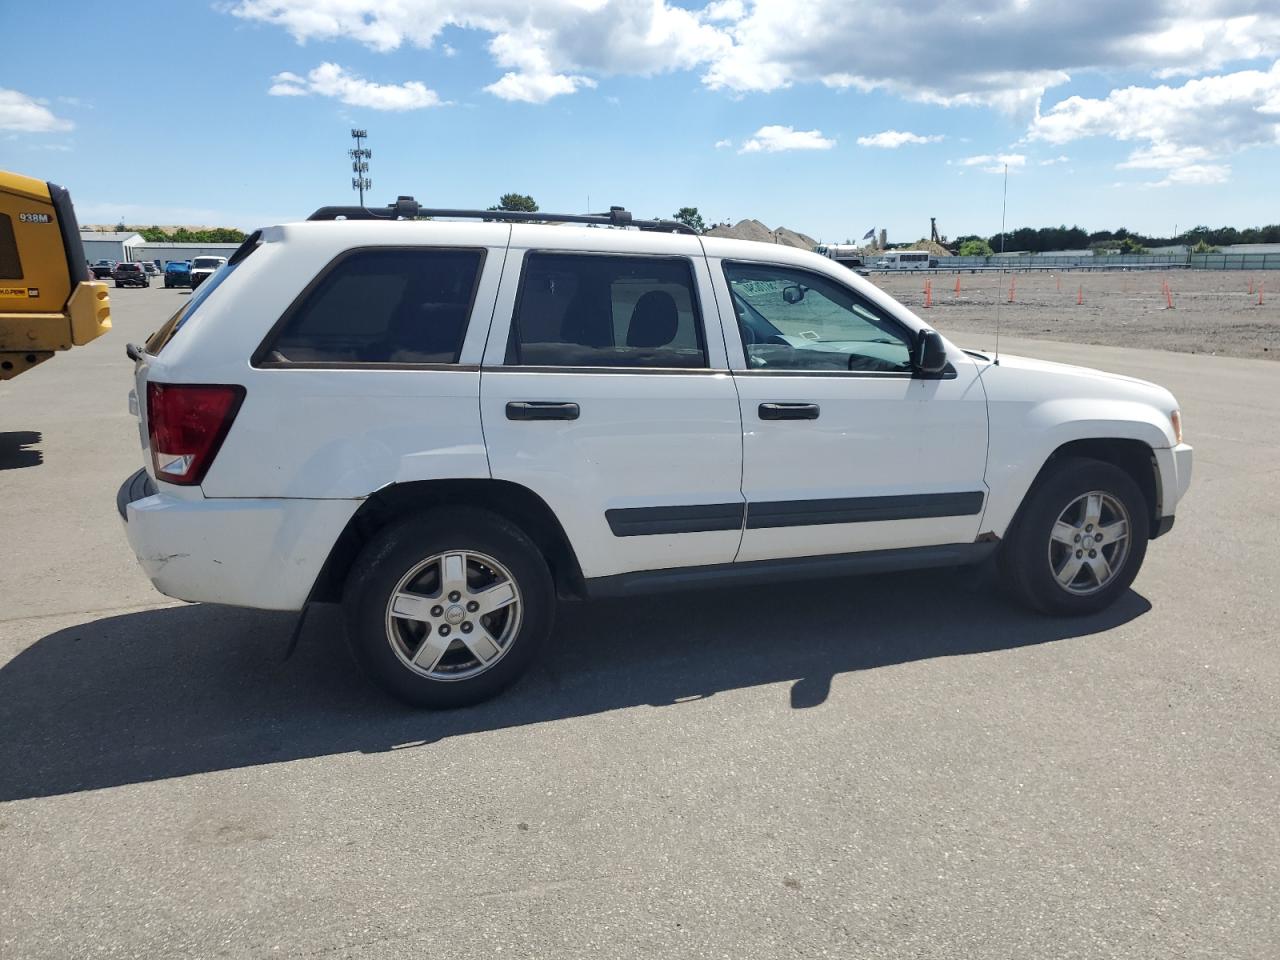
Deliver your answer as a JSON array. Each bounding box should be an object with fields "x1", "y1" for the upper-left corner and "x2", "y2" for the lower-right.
[{"x1": 343, "y1": 507, "x2": 556, "y2": 709}]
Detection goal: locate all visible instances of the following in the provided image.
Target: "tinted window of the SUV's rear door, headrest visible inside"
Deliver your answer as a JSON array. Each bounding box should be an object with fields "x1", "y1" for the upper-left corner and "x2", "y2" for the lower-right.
[{"x1": 507, "y1": 253, "x2": 707, "y2": 367}]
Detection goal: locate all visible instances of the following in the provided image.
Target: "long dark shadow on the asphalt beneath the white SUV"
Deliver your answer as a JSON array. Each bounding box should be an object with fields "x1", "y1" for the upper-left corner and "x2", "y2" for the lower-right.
[{"x1": 0, "y1": 570, "x2": 1151, "y2": 801}]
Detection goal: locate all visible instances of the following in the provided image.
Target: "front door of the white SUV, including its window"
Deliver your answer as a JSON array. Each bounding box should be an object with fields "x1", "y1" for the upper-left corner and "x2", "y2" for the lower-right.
[{"x1": 709, "y1": 257, "x2": 987, "y2": 561}]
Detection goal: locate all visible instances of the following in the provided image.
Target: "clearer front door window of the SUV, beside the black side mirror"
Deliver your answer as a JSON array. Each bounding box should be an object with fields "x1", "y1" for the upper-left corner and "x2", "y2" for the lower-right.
[{"x1": 724, "y1": 262, "x2": 911, "y2": 374}]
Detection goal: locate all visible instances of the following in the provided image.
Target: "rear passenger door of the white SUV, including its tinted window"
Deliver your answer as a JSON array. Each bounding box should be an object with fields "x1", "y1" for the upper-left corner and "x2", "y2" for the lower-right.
[{"x1": 480, "y1": 225, "x2": 744, "y2": 577}]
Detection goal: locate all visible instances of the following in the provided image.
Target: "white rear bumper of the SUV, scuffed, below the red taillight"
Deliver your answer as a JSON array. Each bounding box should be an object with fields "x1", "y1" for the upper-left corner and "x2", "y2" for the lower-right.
[{"x1": 116, "y1": 471, "x2": 360, "y2": 611}]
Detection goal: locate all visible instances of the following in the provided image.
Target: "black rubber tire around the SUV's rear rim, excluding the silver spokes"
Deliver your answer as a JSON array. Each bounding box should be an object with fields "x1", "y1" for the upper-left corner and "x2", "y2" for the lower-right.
[{"x1": 343, "y1": 507, "x2": 556, "y2": 709}]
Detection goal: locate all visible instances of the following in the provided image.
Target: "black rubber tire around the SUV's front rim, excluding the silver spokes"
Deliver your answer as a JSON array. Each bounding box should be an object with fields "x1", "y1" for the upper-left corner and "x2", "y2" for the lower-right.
[{"x1": 998, "y1": 457, "x2": 1151, "y2": 617}]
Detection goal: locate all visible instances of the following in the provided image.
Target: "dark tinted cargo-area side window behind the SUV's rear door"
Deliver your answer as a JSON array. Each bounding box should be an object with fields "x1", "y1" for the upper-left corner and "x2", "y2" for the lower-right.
[{"x1": 259, "y1": 250, "x2": 484, "y2": 365}]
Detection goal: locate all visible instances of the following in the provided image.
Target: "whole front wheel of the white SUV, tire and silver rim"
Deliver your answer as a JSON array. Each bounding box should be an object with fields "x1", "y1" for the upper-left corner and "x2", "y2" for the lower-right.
[{"x1": 1000, "y1": 458, "x2": 1149, "y2": 616}]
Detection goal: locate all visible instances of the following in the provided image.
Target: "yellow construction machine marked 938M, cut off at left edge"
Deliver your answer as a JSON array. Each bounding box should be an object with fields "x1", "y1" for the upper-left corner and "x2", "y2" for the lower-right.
[{"x1": 0, "y1": 170, "x2": 111, "y2": 380}]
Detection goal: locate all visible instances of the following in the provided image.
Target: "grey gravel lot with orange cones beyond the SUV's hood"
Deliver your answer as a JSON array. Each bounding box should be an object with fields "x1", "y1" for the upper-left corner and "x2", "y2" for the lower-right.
[{"x1": 870, "y1": 270, "x2": 1280, "y2": 360}]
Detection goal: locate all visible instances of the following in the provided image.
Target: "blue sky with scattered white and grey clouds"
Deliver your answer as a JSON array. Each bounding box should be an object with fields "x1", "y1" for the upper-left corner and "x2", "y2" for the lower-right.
[{"x1": 0, "y1": 0, "x2": 1280, "y2": 241}]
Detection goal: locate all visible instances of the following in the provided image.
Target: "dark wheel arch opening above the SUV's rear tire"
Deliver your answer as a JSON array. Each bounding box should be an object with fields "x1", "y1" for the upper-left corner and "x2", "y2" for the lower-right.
[{"x1": 308, "y1": 479, "x2": 586, "y2": 603}]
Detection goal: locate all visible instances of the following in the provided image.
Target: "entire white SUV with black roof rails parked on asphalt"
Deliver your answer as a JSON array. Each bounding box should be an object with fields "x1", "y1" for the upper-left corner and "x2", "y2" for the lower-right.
[{"x1": 118, "y1": 200, "x2": 1192, "y2": 707}]
